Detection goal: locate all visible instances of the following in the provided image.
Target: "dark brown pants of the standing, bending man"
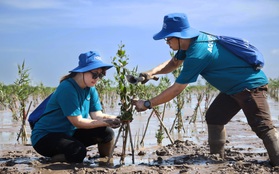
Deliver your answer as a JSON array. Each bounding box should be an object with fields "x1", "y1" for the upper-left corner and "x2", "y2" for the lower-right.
[{"x1": 205, "y1": 85, "x2": 274, "y2": 139}]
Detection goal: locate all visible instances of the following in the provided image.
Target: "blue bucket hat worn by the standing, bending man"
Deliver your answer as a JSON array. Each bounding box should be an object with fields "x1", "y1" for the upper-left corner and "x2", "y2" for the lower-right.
[{"x1": 153, "y1": 13, "x2": 200, "y2": 40}]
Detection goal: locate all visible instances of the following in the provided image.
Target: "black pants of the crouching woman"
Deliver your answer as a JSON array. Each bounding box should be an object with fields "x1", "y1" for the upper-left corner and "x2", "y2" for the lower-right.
[{"x1": 34, "y1": 127, "x2": 114, "y2": 163}]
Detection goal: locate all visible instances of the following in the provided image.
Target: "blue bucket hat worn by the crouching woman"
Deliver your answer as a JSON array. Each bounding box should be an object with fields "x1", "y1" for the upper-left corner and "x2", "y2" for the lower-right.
[{"x1": 70, "y1": 51, "x2": 112, "y2": 72}]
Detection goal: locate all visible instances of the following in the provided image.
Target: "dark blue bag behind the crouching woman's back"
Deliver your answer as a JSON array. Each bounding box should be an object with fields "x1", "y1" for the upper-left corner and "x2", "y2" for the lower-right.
[{"x1": 28, "y1": 94, "x2": 52, "y2": 130}]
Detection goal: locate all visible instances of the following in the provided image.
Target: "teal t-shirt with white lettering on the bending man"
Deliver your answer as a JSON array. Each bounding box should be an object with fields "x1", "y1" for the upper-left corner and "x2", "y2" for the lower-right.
[{"x1": 175, "y1": 33, "x2": 268, "y2": 95}]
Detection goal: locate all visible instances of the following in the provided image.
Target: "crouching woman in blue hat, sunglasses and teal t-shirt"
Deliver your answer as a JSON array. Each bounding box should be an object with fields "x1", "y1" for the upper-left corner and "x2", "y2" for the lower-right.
[{"x1": 31, "y1": 51, "x2": 120, "y2": 163}]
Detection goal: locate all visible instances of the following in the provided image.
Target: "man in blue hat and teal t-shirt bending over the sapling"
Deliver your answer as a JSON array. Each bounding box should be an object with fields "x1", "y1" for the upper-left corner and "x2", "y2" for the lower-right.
[{"x1": 133, "y1": 13, "x2": 279, "y2": 166}]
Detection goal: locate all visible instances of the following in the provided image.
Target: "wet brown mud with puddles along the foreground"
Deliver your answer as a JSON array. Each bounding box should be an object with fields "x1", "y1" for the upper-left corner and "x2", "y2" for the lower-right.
[{"x1": 0, "y1": 136, "x2": 279, "y2": 174}]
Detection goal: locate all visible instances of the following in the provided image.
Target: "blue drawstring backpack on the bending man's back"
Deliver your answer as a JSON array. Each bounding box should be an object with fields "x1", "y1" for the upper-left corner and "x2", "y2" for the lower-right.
[{"x1": 203, "y1": 32, "x2": 264, "y2": 70}]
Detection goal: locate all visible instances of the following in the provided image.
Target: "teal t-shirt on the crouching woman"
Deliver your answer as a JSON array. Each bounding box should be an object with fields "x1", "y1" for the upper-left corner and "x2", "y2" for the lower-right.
[{"x1": 31, "y1": 78, "x2": 102, "y2": 146}]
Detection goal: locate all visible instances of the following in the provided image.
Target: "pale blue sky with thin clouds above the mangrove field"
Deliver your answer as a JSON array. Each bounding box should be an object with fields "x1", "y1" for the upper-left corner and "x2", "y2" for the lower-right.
[{"x1": 0, "y1": 0, "x2": 279, "y2": 87}]
